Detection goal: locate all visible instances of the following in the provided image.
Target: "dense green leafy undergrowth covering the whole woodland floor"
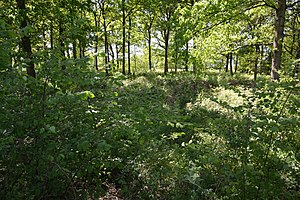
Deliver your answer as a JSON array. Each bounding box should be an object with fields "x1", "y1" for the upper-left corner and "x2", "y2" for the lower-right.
[{"x1": 0, "y1": 70, "x2": 300, "y2": 199}]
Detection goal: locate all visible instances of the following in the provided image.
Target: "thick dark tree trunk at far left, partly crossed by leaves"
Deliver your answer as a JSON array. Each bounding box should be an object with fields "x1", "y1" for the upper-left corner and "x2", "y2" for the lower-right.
[{"x1": 17, "y1": 0, "x2": 36, "y2": 78}]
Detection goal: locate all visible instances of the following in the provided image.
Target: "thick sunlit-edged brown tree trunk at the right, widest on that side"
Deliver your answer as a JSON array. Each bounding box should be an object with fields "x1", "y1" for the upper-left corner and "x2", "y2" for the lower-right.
[{"x1": 271, "y1": 0, "x2": 286, "y2": 80}]
